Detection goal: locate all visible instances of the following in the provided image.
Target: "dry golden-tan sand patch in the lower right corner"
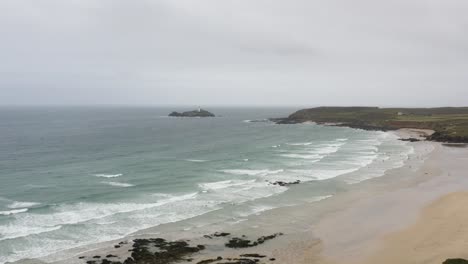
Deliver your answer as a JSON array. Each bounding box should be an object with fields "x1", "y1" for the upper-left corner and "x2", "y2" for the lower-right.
[{"x1": 362, "y1": 192, "x2": 468, "y2": 264}]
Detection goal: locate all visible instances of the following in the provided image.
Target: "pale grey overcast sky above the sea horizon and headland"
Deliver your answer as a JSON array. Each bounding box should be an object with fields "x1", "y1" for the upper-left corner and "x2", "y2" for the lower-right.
[{"x1": 0, "y1": 0, "x2": 468, "y2": 106}]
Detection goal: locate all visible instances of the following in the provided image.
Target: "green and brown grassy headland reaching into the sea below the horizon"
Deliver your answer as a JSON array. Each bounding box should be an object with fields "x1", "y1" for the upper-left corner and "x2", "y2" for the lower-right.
[{"x1": 279, "y1": 107, "x2": 468, "y2": 143}]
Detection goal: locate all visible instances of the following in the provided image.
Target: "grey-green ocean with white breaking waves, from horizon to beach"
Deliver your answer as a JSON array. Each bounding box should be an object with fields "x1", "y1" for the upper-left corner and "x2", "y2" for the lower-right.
[{"x1": 0, "y1": 107, "x2": 414, "y2": 263}]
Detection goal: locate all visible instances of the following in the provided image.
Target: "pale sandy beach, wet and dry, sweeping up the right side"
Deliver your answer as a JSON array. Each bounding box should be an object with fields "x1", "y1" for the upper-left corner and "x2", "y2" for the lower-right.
[{"x1": 276, "y1": 130, "x2": 468, "y2": 264}]
